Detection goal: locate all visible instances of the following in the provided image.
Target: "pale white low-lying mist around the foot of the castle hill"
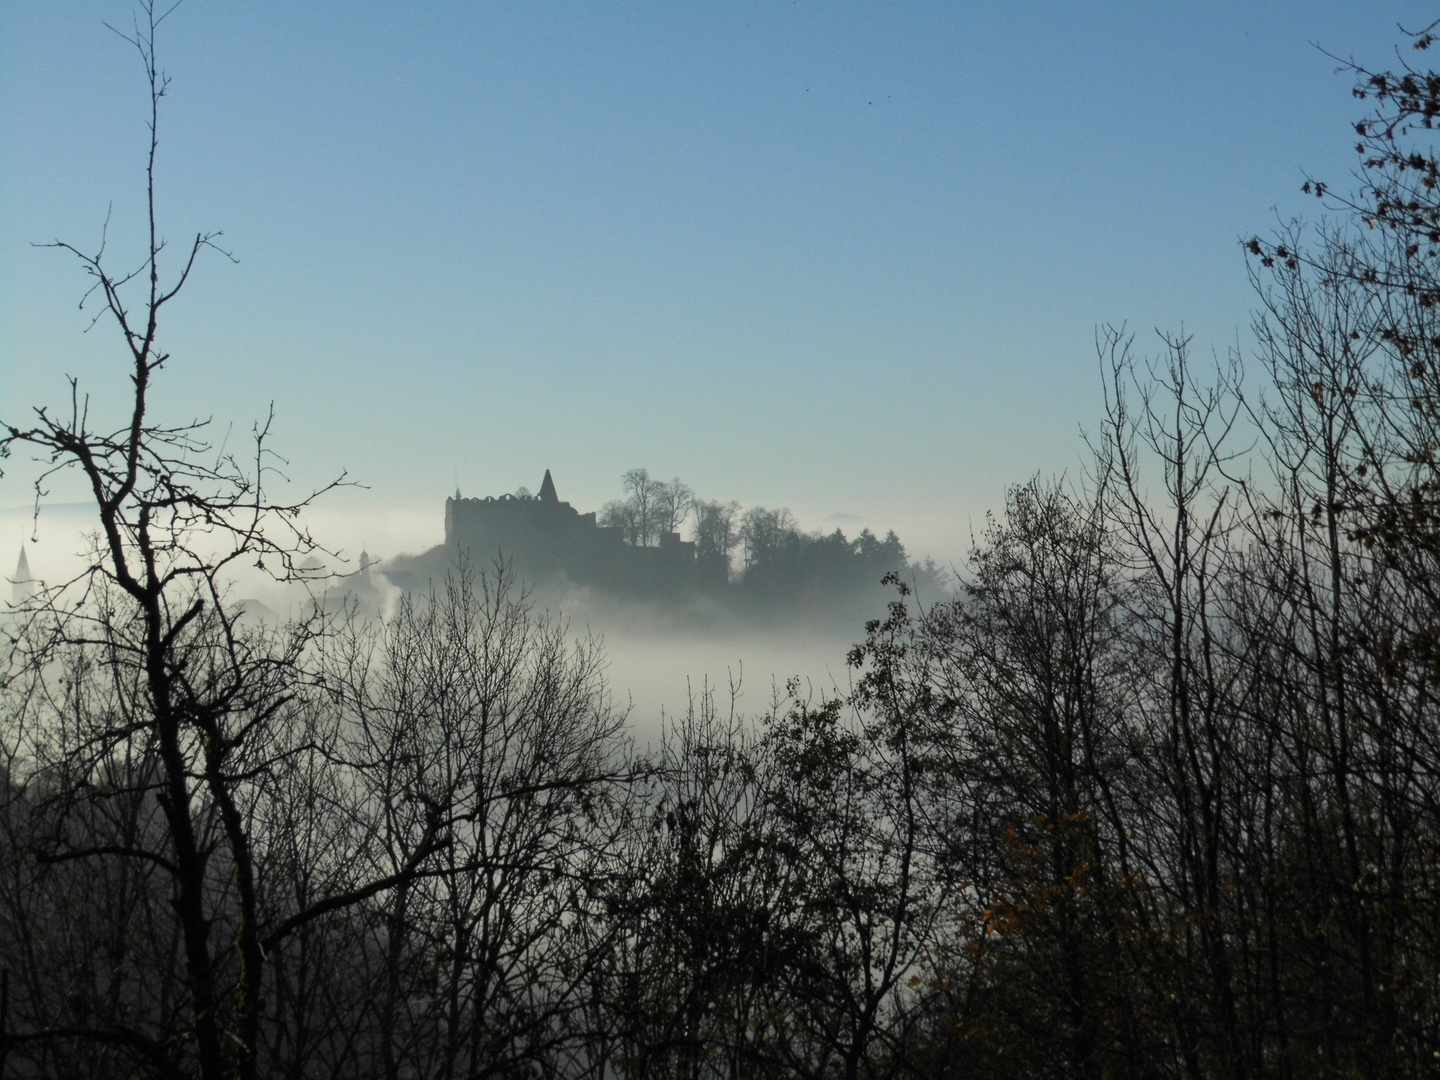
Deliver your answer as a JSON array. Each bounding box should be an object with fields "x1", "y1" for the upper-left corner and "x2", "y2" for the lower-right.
[{"x1": 0, "y1": 503, "x2": 940, "y2": 742}]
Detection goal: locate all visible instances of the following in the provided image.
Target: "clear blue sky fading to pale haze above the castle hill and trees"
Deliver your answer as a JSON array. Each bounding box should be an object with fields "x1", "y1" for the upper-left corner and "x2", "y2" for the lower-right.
[{"x1": 0, "y1": 0, "x2": 1433, "y2": 567}]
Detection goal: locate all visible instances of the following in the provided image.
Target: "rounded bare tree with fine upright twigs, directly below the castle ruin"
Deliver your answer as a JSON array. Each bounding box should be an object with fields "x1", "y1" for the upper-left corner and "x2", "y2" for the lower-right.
[{"x1": 300, "y1": 570, "x2": 644, "y2": 1077}]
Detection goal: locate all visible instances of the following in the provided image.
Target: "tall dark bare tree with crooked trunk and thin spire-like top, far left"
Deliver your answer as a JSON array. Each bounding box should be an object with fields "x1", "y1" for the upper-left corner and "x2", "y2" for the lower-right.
[{"x1": 0, "y1": 0, "x2": 448, "y2": 1080}]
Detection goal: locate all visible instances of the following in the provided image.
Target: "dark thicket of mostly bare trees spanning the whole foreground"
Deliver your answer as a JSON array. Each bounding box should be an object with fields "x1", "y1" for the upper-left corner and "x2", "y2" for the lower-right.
[{"x1": 0, "y1": 8, "x2": 1440, "y2": 1080}]
